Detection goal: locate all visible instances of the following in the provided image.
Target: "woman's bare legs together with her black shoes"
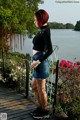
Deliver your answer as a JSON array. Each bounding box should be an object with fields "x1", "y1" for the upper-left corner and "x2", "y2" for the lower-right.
[{"x1": 32, "y1": 79, "x2": 49, "y2": 119}]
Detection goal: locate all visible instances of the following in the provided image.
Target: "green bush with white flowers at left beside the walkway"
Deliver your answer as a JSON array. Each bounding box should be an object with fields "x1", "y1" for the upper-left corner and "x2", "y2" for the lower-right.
[{"x1": 0, "y1": 52, "x2": 26, "y2": 91}]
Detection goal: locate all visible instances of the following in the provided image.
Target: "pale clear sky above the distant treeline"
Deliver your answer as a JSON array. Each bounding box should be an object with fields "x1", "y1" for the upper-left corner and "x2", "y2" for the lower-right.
[{"x1": 38, "y1": 0, "x2": 80, "y2": 25}]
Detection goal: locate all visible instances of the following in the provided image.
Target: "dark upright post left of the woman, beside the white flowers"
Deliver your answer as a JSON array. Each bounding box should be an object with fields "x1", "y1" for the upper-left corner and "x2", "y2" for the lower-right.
[{"x1": 26, "y1": 54, "x2": 30, "y2": 97}]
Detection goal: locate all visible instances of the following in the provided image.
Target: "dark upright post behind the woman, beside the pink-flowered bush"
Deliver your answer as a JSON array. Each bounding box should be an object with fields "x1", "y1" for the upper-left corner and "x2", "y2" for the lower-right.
[{"x1": 53, "y1": 60, "x2": 59, "y2": 114}]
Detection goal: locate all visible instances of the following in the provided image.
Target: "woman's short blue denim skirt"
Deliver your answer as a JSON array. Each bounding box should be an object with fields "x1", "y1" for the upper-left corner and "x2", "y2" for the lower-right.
[{"x1": 33, "y1": 52, "x2": 49, "y2": 80}]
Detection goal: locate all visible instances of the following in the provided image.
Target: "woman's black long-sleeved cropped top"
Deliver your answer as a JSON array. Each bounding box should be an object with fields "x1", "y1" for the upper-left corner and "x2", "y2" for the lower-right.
[{"x1": 33, "y1": 25, "x2": 53, "y2": 62}]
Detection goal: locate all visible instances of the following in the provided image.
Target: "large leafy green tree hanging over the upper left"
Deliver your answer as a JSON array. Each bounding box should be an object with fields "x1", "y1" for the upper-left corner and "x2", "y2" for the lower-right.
[{"x1": 0, "y1": 0, "x2": 42, "y2": 49}]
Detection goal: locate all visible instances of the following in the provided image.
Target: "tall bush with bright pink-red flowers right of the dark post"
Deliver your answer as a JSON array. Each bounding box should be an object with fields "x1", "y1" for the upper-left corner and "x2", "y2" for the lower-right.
[{"x1": 58, "y1": 59, "x2": 80, "y2": 115}]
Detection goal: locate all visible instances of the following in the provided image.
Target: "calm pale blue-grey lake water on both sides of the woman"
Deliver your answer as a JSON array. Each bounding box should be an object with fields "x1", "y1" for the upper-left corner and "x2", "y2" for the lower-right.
[{"x1": 11, "y1": 29, "x2": 80, "y2": 61}]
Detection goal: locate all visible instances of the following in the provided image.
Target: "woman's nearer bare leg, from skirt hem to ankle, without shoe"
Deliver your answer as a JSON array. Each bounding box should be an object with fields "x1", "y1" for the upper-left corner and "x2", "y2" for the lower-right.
[{"x1": 36, "y1": 79, "x2": 47, "y2": 110}]
